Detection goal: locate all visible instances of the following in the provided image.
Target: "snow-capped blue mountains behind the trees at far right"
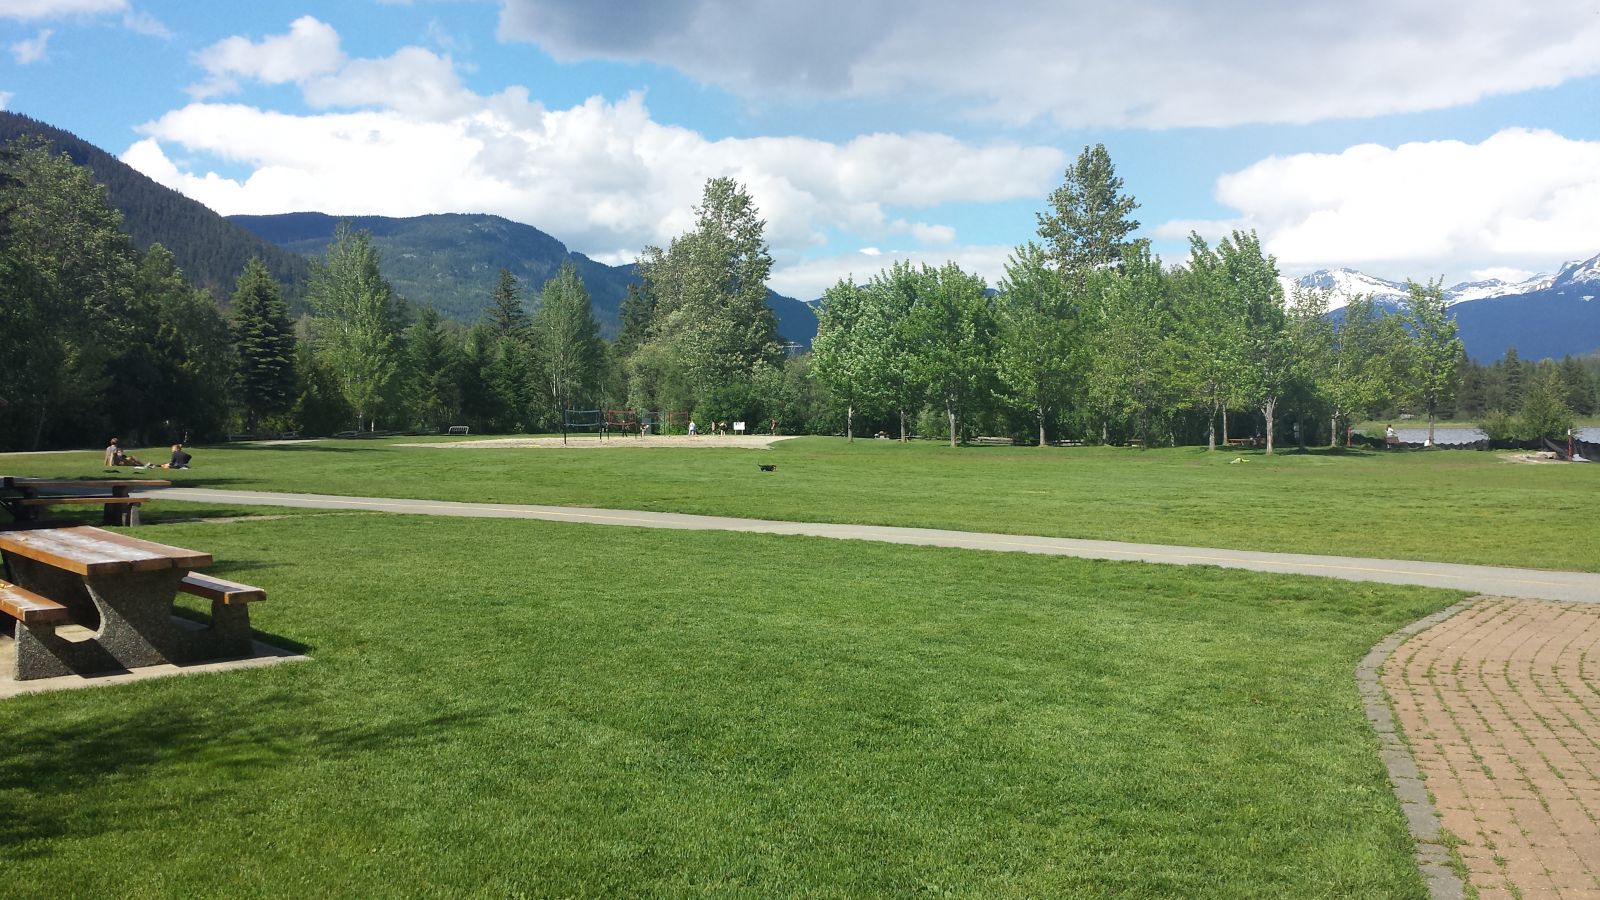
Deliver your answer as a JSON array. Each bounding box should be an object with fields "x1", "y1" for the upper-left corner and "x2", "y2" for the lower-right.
[{"x1": 1280, "y1": 255, "x2": 1600, "y2": 364}]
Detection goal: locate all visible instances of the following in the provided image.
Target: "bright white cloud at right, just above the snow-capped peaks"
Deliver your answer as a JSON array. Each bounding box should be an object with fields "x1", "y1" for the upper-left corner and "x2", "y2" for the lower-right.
[{"x1": 1155, "y1": 128, "x2": 1600, "y2": 279}]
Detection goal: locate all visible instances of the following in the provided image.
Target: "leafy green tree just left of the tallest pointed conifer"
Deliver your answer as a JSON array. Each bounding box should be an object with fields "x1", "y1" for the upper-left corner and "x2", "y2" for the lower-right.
[{"x1": 995, "y1": 242, "x2": 1083, "y2": 447}]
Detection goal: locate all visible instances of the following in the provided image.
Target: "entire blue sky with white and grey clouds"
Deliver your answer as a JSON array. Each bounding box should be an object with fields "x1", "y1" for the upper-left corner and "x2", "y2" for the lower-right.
[{"x1": 0, "y1": 0, "x2": 1600, "y2": 298}]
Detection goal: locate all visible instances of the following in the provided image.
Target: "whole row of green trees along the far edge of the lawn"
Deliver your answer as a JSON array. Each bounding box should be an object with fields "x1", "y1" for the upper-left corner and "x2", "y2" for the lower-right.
[{"x1": 0, "y1": 141, "x2": 1595, "y2": 450}]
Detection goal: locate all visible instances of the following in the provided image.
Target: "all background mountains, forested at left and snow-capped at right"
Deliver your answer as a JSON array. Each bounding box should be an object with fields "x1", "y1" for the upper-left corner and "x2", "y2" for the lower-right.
[{"x1": 9, "y1": 110, "x2": 1600, "y2": 362}]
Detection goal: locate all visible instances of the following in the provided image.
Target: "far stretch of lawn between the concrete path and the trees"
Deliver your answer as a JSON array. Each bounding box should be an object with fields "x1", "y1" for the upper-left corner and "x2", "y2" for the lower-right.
[{"x1": 15, "y1": 437, "x2": 1600, "y2": 572}]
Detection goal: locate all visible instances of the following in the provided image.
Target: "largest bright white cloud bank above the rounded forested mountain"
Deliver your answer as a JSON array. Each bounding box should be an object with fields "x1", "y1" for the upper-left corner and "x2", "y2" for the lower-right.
[{"x1": 123, "y1": 16, "x2": 1066, "y2": 296}]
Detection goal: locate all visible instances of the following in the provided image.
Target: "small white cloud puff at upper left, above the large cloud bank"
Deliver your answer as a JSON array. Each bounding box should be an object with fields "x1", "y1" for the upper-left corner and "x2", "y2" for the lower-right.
[{"x1": 189, "y1": 16, "x2": 344, "y2": 98}]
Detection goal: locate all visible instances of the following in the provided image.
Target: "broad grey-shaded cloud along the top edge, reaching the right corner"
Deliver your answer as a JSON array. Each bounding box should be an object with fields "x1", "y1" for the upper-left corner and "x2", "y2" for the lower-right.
[{"x1": 499, "y1": 0, "x2": 1600, "y2": 128}]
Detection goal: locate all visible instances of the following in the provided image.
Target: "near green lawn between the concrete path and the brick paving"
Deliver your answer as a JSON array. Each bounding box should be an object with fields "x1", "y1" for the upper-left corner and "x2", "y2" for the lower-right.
[{"x1": 0, "y1": 509, "x2": 1456, "y2": 898}]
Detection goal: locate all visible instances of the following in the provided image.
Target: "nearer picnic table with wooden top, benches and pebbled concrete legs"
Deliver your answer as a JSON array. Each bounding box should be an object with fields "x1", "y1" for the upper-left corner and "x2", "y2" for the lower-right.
[{"x1": 0, "y1": 525, "x2": 266, "y2": 681}]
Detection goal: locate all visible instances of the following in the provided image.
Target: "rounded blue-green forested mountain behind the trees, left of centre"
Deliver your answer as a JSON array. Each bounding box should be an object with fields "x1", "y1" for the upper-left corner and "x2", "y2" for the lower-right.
[{"x1": 229, "y1": 213, "x2": 816, "y2": 346}]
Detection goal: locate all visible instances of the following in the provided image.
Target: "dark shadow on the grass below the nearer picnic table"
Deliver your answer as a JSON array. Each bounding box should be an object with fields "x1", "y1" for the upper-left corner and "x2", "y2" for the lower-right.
[{"x1": 0, "y1": 692, "x2": 482, "y2": 858}]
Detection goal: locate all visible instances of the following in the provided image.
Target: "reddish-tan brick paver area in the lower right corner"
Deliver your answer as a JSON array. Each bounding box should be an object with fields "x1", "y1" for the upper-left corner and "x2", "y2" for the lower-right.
[{"x1": 1381, "y1": 599, "x2": 1600, "y2": 900}]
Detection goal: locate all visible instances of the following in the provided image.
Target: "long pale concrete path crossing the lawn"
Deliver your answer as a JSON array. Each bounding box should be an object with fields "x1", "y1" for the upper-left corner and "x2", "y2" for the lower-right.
[{"x1": 150, "y1": 487, "x2": 1600, "y2": 604}]
